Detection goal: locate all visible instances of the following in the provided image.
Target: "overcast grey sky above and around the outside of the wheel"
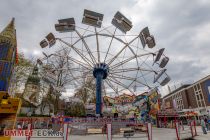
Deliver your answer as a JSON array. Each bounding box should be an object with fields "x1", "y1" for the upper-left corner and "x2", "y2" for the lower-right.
[{"x1": 0, "y1": 0, "x2": 210, "y2": 95}]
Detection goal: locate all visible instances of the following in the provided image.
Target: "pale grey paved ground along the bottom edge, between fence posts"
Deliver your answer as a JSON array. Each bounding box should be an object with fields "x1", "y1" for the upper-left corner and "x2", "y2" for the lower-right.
[{"x1": 12, "y1": 127, "x2": 210, "y2": 140}]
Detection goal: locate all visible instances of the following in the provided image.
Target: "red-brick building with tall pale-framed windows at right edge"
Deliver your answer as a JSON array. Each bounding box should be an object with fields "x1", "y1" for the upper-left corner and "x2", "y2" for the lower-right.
[{"x1": 163, "y1": 75, "x2": 210, "y2": 116}]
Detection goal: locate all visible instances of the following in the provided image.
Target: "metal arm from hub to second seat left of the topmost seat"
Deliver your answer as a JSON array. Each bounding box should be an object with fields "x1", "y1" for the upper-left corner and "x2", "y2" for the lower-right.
[{"x1": 57, "y1": 38, "x2": 94, "y2": 67}]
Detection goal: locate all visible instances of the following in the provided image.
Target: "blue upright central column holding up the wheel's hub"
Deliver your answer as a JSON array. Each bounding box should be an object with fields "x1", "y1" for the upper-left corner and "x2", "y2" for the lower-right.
[{"x1": 96, "y1": 71, "x2": 104, "y2": 115}]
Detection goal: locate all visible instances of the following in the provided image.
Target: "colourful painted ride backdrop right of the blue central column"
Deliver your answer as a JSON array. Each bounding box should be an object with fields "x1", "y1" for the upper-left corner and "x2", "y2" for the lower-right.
[{"x1": 103, "y1": 89, "x2": 160, "y2": 122}]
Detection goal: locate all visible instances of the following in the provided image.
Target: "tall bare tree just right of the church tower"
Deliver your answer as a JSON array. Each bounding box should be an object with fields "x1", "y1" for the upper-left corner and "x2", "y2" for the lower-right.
[{"x1": 41, "y1": 49, "x2": 76, "y2": 114}]
